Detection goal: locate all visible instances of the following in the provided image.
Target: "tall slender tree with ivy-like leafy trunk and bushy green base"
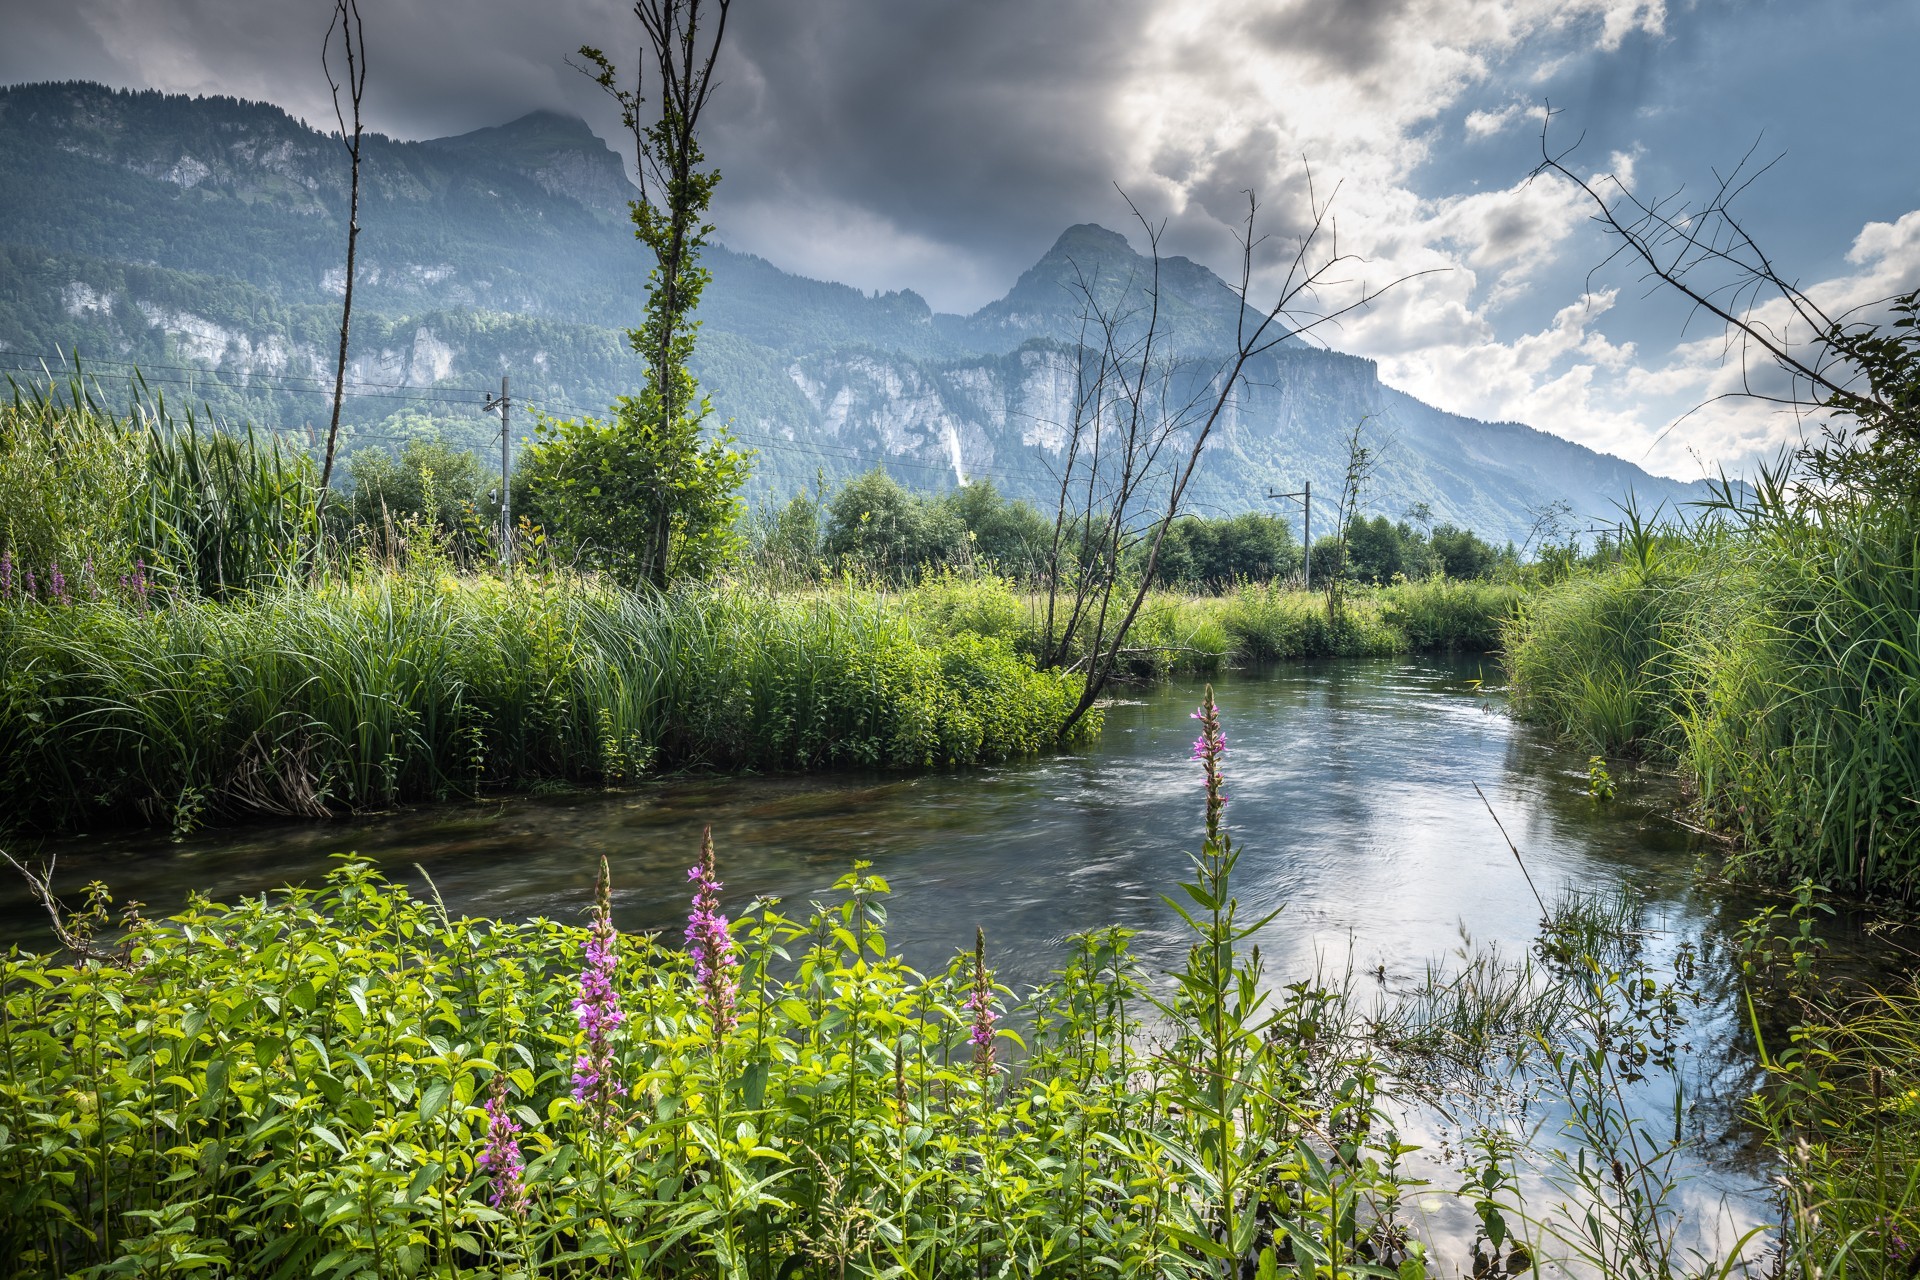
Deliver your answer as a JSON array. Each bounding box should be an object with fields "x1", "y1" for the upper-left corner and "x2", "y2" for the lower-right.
[{"x1": 528, "y1": 0, "x2": 753, "y2": 587}]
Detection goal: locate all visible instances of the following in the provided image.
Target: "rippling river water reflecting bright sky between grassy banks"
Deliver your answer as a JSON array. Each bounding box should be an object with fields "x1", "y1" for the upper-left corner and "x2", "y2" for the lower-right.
[{"x1": 11, "y1": 658, "x2": 1904, "y2": 1274}]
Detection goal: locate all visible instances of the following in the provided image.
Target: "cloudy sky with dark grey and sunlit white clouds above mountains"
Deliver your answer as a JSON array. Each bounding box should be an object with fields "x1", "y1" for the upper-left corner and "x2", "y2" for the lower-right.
[{"x1": 0, "y1": 0, "x2": 1920, "y2": 476}]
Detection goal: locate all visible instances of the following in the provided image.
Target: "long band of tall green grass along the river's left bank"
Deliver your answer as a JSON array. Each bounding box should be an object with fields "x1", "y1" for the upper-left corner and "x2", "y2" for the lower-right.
[{"x1": 0, "y1": 568, "x2": 1096, "y2": 829}]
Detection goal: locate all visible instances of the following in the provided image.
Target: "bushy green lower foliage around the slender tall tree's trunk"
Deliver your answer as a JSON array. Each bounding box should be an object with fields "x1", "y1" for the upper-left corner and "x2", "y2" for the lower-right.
[{"x1": 520, "y1": 395, "x2": 753, "y2": 585}]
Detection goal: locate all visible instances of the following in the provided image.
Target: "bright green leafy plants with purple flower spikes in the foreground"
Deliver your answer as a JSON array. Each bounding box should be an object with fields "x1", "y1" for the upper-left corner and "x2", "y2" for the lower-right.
[{"x1": 0, "y1": 721, "x2": 1427, "y2": 1280}]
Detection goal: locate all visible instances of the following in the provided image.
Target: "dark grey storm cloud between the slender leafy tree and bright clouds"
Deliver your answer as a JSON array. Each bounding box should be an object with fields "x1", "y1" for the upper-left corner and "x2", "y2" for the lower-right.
[{"x1": 712, "y1": 0, "x2": 1148, "y2": 282}]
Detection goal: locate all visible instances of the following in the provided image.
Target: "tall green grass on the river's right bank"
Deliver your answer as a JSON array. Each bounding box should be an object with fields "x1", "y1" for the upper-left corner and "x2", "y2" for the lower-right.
[{"x1": 1507, "y1": 476, "x2": 1920, "y2": 898}]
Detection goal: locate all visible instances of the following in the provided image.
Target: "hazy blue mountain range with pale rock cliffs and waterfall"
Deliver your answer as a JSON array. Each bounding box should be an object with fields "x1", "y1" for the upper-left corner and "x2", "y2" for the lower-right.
[{"x1": 0, "y1": 83, "x2": 1701, "y2": 539}]
